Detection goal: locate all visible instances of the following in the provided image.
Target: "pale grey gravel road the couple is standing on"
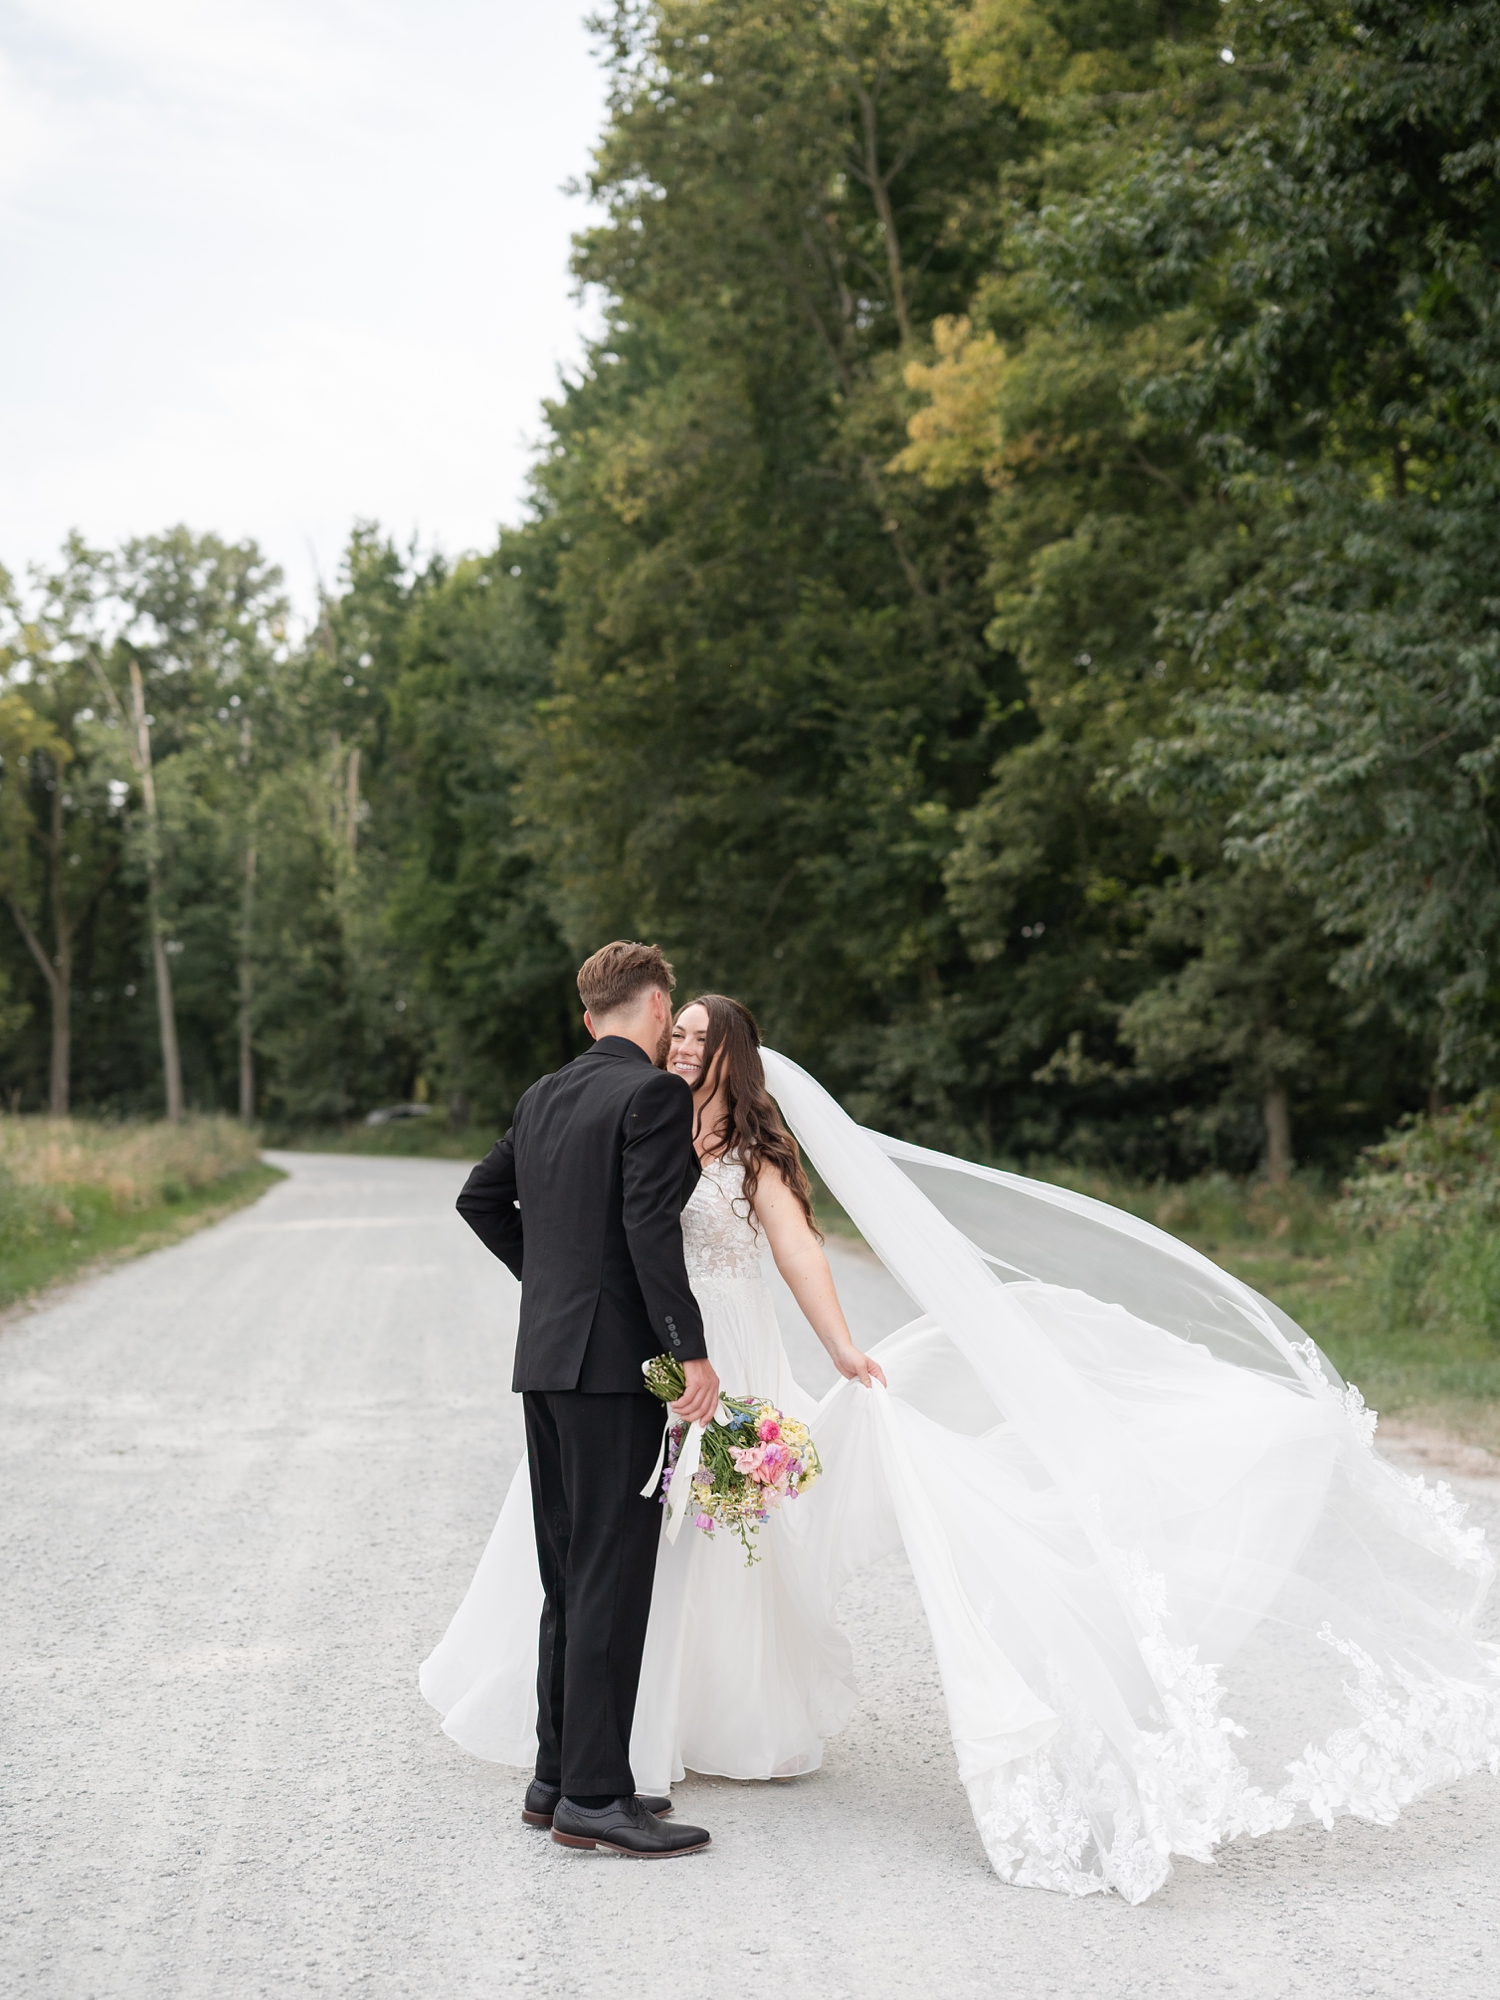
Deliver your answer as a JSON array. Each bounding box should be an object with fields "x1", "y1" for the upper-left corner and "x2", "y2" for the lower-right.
[{"x1": 0, "y1": 1154, "x2": 1500, "y2": 2000}]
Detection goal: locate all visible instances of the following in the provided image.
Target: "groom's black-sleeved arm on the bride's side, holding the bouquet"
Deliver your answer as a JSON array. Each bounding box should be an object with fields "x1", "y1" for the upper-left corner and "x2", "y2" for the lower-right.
[{"x1": 622, "y1": 1070, "x2": 708, "y2": 1362}]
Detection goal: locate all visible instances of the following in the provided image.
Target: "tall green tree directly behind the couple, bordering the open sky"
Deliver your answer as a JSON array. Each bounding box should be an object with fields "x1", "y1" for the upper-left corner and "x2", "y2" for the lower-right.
[{"x1": 516, "y1": 0, "x2": 1012, "y2": 1112}]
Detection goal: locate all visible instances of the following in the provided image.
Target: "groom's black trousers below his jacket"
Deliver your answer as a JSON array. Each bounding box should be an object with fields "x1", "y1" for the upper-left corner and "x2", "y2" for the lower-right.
[{"x1": 522, "y1": 1390, "x2": 664, "y2": 1798}]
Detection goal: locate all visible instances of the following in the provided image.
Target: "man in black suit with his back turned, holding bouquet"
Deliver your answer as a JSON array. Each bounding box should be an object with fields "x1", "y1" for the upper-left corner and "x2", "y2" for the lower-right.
[{"x1": 458, "y1": 944, "x2": 718, "y2": 1856}]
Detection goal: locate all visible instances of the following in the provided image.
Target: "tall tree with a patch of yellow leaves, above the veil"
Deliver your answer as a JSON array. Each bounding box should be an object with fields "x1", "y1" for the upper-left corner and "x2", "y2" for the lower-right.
[{"x1": 894, "y1": 0, "x2": 1308, "y2": 1166}]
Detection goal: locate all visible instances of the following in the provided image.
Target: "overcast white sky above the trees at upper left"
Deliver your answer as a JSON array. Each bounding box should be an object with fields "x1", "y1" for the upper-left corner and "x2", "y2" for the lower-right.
[{"x1": 0, "y1": 0, "x2": 604, "y2": 606}]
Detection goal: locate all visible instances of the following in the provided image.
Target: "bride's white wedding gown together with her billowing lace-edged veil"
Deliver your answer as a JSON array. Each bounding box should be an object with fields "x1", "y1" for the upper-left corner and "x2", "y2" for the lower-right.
[{"x1": 422, "y1": 1050, "x2": 1500, "y2": 1902}]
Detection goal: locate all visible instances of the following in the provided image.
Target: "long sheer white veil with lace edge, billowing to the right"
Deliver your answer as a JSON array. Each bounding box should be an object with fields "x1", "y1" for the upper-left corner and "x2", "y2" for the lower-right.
[{"x1": 764, "y1": 1050, "x2": 1500, "y2": 1900}]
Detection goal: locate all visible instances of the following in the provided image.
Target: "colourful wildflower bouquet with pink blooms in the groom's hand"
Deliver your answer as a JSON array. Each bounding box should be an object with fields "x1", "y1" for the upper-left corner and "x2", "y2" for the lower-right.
[{"x1": 642, "y1": 1354, "x2": 822, "y2": 1568}]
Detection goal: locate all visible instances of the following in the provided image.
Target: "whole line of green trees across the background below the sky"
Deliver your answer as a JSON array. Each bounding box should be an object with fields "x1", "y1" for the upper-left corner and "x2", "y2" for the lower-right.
[{"x1": 0, "y1": 0, "x2": 1500, "y2": 1174}]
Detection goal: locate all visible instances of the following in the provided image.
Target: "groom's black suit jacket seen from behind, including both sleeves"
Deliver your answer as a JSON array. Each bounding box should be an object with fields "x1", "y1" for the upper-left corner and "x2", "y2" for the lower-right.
[{"x1": 458, "y1": 1034, "x2": 708, "y2": 1394}]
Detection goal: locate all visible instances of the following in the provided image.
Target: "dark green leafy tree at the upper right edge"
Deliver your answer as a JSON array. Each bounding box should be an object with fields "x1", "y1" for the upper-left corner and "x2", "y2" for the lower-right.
[{"x1": 1044, "y1": 0, "x2": 1500, "y2": 1088}]
